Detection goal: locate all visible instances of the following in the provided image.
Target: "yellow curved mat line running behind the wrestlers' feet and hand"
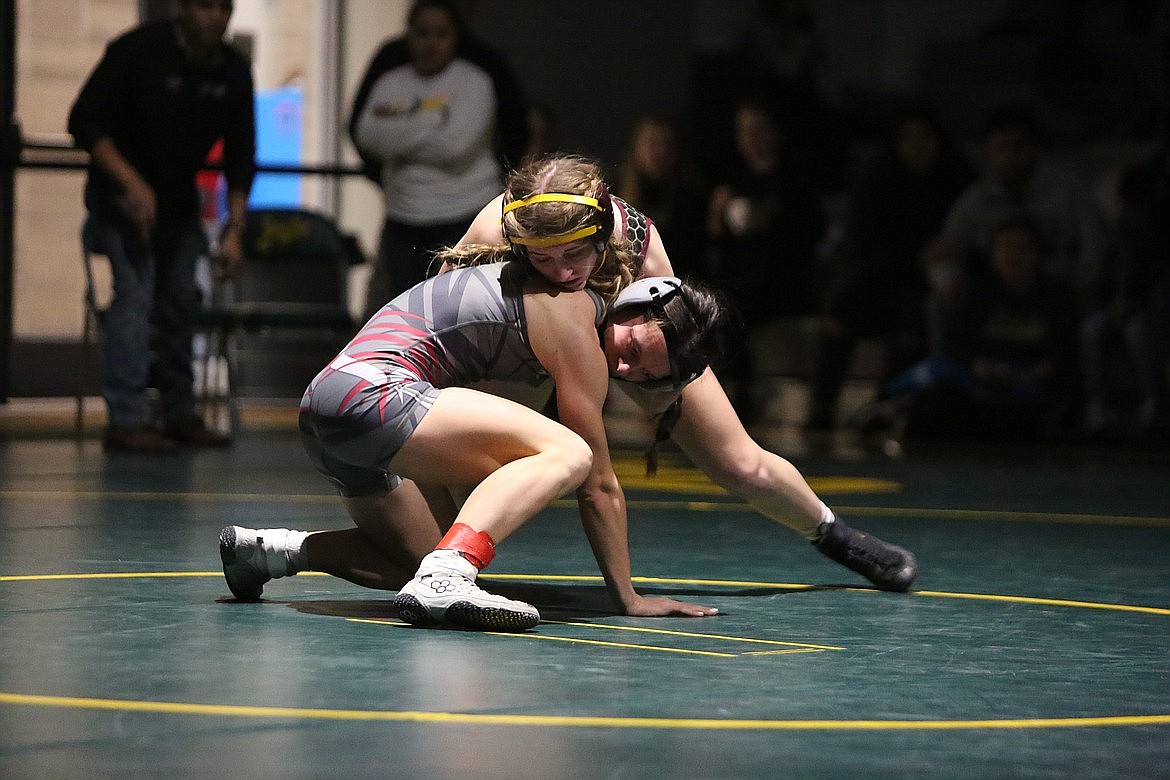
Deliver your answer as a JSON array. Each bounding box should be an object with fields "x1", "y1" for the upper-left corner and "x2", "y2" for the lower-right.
[{"x1": 0, "y1": 572, "x2": 1170, "y2": 616}]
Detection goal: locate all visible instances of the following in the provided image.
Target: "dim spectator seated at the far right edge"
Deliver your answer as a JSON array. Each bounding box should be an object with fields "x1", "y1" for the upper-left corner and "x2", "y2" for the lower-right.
[{"x1": 1081, "y1": 141, "x2": 1170, "y2": 436}]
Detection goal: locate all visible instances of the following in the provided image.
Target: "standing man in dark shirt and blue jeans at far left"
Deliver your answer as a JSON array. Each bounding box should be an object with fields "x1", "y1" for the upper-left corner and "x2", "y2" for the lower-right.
[{"x1": 69, "y1": 0, "x2": 255, "y2": 453}]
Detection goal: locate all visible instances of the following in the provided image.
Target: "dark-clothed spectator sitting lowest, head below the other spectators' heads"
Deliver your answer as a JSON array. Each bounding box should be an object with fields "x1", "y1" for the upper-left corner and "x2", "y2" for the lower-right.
[{"x1": 859, "y1": 216, "x2": 1078, "y2": 440}]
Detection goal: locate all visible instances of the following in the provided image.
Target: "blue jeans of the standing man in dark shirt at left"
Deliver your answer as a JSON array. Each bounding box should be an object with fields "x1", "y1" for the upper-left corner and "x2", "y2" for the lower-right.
[{"x1": 85, "y1": 214, "x2": 207, "y2": 426}]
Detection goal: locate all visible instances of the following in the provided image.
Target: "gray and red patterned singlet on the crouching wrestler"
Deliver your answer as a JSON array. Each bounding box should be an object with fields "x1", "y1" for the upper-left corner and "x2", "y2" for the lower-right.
[{"x1": 300, "y1": 263, "x2": 605, "y2": 496}]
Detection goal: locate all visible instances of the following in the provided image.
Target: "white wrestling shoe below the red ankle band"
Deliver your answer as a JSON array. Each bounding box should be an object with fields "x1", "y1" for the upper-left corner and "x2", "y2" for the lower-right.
[{"x1": 394, "y1": 550, "x2": 541, "y2": 631}]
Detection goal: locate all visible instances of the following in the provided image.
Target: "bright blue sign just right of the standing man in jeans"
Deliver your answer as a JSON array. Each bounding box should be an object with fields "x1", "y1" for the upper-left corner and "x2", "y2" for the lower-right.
[{"x1": 248, "y1": 87, "x2": 304, "y2": 208}]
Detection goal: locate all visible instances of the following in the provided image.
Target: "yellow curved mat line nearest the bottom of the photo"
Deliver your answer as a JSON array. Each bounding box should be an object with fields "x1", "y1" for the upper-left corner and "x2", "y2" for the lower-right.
[{"x1": 0, "y1": 692, "x2": 1170, "y2": 731}]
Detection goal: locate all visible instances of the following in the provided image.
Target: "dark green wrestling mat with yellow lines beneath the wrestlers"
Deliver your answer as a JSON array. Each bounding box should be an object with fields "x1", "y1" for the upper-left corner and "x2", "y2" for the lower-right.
[{"x1": 0, "y1": 399, "x2": 1170, "y2": 780}]
